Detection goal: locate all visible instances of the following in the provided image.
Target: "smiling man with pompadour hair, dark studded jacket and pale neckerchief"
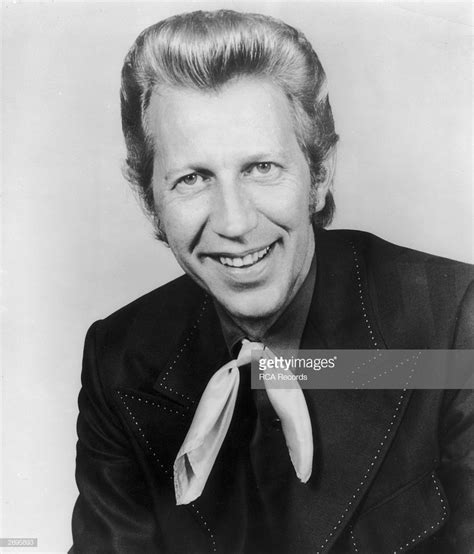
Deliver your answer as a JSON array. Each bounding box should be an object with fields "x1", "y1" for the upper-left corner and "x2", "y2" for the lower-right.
[{"x1": 73, "y1": 11, "x2": 474, "y2": 553}]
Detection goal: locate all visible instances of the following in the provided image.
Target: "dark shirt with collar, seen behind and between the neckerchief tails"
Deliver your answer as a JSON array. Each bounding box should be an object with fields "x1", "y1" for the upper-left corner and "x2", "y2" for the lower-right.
[{"x1": 216, "y1": 252, "x2": 316, "y2": 554}]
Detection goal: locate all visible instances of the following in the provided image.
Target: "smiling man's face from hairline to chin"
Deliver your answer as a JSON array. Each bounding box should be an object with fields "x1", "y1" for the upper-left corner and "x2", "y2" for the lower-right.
[{"x1": 148, "y1": 78, "x2": 314, "y2": 324}]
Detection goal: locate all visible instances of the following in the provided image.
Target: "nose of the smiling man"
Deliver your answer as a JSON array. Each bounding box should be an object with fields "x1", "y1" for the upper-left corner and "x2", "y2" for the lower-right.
[{"x1": 211, "y1": 179, "x2": 258, "y2": 239}]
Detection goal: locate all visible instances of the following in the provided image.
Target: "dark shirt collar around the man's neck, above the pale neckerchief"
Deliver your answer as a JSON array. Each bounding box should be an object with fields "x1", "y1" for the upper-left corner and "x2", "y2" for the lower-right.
[{"x1": 214, "y1": 248, "x2": 316, "y2": 357}]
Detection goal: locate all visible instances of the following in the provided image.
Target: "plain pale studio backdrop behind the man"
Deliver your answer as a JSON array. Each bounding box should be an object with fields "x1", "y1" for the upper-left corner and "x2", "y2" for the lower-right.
[{"x1": 0, "y1": 2, "x2": 473, "y2": 552}]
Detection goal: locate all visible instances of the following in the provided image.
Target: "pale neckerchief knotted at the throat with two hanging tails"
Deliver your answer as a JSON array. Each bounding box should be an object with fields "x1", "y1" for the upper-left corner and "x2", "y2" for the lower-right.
[{"x1": 173, "y1": 340, "x2": 313, "y2": 505}]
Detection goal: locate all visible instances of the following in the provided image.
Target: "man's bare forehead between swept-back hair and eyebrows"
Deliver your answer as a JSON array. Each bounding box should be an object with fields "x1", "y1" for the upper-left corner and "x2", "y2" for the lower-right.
[{"x1": 147, "y1": 78, "x2": 299, "y2": 163}]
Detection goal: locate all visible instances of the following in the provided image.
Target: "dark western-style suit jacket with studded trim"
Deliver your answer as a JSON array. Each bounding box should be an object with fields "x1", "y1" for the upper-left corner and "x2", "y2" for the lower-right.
[{"x1": 73, "y1": 227, "x2": 474, "y2": 554}]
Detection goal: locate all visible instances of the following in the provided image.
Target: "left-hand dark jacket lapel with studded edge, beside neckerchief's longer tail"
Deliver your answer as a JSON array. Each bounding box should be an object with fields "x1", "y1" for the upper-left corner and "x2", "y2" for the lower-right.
[{"x1": 116, "y1": 287, "x2": 229, "y2": 503}]
